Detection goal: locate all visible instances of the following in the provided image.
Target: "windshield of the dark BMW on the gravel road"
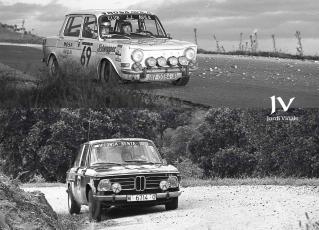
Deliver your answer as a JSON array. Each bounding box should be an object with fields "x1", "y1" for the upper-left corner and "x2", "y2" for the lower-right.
[{"x1": 91, "y1": 141, "x2": 162, "y2": 165}]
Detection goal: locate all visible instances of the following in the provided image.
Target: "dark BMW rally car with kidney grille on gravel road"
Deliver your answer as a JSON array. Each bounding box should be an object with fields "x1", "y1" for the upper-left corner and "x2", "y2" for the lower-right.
[{"x1": 66, "y1": 138, "x2": 181, "y2": 221}]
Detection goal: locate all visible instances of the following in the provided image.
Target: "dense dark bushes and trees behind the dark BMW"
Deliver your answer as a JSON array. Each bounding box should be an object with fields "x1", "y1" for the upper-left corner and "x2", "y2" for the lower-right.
[{"x1": 0, "y1": 108, "x2": 319, "y2": 183}]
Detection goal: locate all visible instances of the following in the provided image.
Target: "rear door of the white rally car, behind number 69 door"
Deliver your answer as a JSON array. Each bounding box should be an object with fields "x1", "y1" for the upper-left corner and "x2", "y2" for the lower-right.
[{"x1": 57, "y1": 15, "x2": 83, "y2": 68}]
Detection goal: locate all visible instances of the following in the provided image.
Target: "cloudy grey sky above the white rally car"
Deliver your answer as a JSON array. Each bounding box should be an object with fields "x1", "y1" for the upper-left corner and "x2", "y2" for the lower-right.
[{"x1": 0, "y1": 0, "x2": 319, "y2": 55}]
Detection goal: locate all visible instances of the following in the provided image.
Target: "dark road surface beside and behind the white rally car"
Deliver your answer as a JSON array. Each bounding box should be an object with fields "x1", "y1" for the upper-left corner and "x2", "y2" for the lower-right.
[{"x1": 0, "y1": 45, "x2": 319, "y2": 108}]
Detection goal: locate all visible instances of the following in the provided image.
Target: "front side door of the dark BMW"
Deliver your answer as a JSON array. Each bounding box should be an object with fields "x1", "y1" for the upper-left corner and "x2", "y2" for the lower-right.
[{"x1": 76, "y1": 144, "x2": 90, "y2": 204}]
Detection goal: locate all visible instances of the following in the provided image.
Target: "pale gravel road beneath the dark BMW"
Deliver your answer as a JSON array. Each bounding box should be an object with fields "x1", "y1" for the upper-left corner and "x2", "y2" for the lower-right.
[{"x1": 25, "y1": 185, "x2": 319, "y2": 230}]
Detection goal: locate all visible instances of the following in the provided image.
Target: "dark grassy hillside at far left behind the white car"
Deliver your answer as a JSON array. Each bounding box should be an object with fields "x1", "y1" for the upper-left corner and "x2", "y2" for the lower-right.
[{"x1": 0, "y1": 23, "x2": 42, "y2": 44}]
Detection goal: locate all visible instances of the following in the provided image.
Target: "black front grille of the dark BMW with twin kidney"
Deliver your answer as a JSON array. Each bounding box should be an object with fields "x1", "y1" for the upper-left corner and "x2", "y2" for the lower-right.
[{"x1": 109, "y1": 173, "x2": 168, "y2": 192}]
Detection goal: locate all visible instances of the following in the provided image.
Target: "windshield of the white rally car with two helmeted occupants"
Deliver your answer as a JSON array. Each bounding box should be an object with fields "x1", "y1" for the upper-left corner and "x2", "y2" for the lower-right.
[{"x1": 99, "y1": 14, "x2": 167, "y2": 39}]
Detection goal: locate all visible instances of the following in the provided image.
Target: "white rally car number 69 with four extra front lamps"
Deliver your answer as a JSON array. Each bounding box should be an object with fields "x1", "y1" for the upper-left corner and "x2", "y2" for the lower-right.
[{"x1": 43, "y1": 10, "x2": 197, "y2": 85}]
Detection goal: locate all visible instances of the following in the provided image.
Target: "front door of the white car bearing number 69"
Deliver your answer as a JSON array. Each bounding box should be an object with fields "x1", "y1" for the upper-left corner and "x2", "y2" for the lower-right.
[{"x1": 80, "y1": 15, "x2": 99, "y2": 69}]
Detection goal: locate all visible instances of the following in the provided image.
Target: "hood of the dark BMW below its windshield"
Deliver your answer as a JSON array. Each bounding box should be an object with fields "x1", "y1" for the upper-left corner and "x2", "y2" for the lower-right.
[{"x1": 85, "y1": 164, "x2": 178, "y2": 177}]
